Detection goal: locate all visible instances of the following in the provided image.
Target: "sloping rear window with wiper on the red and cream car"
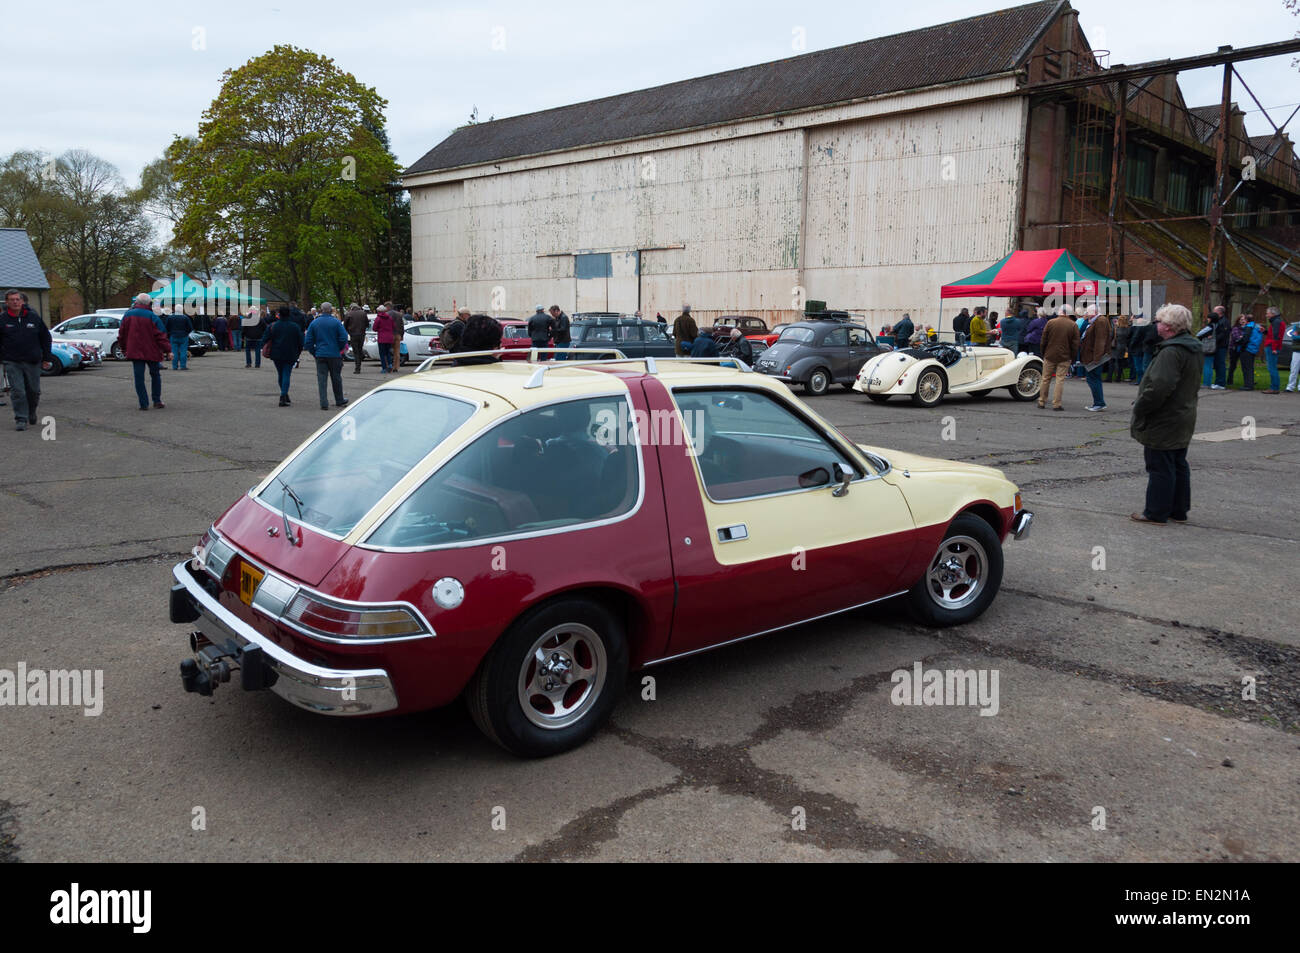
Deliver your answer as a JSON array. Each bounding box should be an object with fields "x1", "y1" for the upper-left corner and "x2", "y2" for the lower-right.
[{"x1": 259, "y1": 389, "x2": 475, "y2": 536}]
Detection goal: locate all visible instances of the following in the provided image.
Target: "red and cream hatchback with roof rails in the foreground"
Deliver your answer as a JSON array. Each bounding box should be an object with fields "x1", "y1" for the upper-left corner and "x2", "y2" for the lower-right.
[{"x1": 170, "y1": 351, "x2": 1032, "y2": 755}]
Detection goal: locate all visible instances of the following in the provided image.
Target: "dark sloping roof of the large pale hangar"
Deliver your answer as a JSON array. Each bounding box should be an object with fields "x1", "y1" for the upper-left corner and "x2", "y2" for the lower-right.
[{"x1": 404, "y1": 0, "x2": 1069, "y2": 176}]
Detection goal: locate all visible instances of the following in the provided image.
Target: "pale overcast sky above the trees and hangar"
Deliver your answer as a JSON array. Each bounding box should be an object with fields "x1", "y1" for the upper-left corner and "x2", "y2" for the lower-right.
[{"x1": 10, "y1": 0, "x2": 1300, "y2": 183}]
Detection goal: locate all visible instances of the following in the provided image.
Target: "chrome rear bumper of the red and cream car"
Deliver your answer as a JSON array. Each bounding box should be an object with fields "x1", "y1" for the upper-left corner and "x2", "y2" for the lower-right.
[{"x1": 172, "y1": 560, "x2": 398, "y2": 715}]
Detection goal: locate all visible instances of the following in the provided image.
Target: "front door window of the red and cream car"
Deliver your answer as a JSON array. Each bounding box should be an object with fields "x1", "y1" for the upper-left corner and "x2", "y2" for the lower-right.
[{"x1": 673, "y1": 390, "x2": 862, "y2": 502}]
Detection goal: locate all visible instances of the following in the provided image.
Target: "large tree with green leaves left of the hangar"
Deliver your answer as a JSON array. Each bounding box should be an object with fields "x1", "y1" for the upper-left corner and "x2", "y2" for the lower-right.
[{"x1": 166, "y1": 46, "x2": 399, "y2": 300}]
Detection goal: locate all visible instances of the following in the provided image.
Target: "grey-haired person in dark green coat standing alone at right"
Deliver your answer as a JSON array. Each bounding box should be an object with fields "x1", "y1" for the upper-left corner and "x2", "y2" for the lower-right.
[{"x1": 1128, "y1": 304, "x2": 1204, "y2": 525}]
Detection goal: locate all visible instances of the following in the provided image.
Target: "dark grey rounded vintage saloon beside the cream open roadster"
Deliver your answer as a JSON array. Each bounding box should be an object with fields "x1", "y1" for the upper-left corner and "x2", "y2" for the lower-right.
[{"x1": 754, "y1": 320, "x2": 885, "y2": 397}]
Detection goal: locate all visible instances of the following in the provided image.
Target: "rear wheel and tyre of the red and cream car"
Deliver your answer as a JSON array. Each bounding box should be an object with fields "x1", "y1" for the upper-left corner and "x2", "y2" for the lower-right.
[{"x1": 465, "y1": 598, "x2": 628, "y2": 758}]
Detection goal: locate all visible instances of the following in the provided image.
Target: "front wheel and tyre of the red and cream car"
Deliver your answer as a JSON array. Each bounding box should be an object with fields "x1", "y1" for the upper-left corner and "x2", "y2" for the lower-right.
[{"x1": 907, "y1": 514, "x2": 1002, "y2": 628}]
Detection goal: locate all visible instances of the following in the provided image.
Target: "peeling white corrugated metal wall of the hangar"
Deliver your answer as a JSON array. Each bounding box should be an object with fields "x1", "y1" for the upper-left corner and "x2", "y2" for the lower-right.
[{"x1": 412, "y1": 91, "x2": 1023, "y2": 326}]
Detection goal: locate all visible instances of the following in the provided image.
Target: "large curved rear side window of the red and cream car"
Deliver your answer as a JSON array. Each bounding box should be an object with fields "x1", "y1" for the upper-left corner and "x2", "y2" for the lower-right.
[{"x1": 367, "y1": 392, "x2": 641, "y2": 547}]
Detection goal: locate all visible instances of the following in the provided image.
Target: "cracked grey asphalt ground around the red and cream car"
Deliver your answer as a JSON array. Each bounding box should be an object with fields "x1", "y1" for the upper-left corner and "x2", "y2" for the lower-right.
[{"x1": 0, "y1": 354, "x2": 1300, "y2": 862}]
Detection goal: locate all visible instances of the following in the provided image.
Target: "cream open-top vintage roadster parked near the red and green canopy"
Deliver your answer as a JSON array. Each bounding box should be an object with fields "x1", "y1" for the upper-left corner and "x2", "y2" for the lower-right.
[{"x1": 853, "y1": 342, "x2": 1043, "y2": 407}]
